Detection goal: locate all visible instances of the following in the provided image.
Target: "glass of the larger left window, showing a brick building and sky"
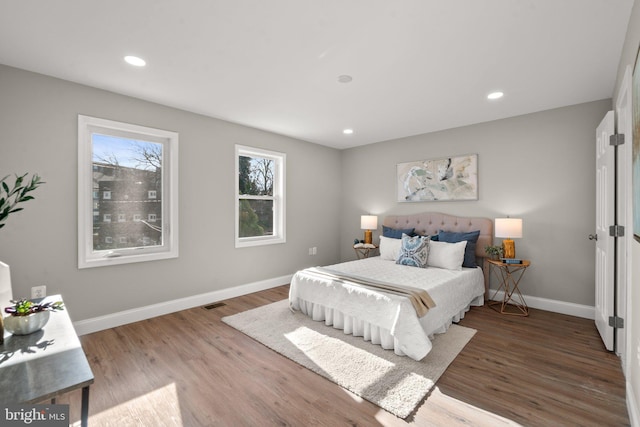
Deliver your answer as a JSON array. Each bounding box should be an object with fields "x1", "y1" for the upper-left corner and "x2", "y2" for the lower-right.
[{"x1": 91, "y1": 133, "x2": 163, "y2": 251}]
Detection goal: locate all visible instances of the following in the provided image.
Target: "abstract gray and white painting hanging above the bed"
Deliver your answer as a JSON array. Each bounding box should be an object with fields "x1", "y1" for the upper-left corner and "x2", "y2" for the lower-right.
[{"x1": 396, "y1": 154, "x2": 478, "y2": 202}]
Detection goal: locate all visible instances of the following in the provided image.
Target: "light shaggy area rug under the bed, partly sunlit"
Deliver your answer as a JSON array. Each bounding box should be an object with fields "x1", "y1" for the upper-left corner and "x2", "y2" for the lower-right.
[{"x1": 222, "y1": 300, "x2": 476, "y2": 418}]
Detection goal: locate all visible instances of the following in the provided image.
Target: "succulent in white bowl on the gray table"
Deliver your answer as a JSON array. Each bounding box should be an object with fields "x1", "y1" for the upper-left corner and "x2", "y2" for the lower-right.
[{"x1": 4, "y1": 298, "x2": 64, "y2": 335}]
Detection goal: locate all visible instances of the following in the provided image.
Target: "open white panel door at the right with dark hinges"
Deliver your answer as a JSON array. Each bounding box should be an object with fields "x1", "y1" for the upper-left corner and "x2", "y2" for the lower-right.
[{"x1": 595, "y1": 111, "x2": 615, "y2": 351}]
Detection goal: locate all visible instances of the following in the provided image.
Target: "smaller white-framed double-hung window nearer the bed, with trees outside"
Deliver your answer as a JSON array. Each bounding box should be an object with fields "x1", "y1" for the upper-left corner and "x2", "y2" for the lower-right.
[{"x1": 235, "y1": 145, "x2": 286, "y2": 248}]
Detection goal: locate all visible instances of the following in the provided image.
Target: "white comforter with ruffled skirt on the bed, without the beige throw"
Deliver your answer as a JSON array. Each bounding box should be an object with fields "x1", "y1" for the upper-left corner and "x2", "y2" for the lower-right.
[{"x1": 289, "y1": 257, "x2": 484, "y2": 360}]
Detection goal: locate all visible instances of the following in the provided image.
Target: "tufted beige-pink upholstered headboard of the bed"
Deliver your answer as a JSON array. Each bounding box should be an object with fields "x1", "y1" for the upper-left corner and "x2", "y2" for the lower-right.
[{"x1": 382, "y1": 212, "x2": 493, "y2": 258}]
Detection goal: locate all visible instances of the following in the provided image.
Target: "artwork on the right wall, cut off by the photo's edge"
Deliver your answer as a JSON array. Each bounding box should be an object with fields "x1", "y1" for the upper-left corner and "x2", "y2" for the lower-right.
[{"x1": 631, "y1": 47, "x2": 640, "y2": 242}]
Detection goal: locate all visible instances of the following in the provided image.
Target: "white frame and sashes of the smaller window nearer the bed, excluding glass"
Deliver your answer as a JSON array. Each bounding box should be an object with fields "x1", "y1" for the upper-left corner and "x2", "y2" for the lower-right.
[{"x1": 234, "y1": 145, "x2": 287, "y2": 248}]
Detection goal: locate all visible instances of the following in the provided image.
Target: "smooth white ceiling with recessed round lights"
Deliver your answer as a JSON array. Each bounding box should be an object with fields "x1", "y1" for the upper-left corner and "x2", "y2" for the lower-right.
[{"x1": 0, "y1": 0, "x2": 633, "y2": 148}]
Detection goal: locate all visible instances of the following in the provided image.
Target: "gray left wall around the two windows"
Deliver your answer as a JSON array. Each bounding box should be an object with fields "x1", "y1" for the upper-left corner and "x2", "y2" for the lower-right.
[{"x1": 0, "y1": 65, "x2": 341, "y2": 321}]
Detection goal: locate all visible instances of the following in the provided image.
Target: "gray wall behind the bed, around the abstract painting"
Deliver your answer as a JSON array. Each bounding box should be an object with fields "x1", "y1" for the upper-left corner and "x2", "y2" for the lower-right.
[{"x1": 341, "y1": 99, "x2": 611, "y2": 306}]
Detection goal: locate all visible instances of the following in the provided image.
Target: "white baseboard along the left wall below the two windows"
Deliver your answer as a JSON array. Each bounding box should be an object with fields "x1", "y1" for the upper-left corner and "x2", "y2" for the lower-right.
[{"x1": 73, "y1": 275, "x2": 292, "y2": 335}]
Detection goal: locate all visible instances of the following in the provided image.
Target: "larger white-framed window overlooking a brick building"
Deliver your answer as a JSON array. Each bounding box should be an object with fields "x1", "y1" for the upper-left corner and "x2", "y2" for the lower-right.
[{"x1": 78, "y1": 115, "x2": 178, "y2": 268}]
